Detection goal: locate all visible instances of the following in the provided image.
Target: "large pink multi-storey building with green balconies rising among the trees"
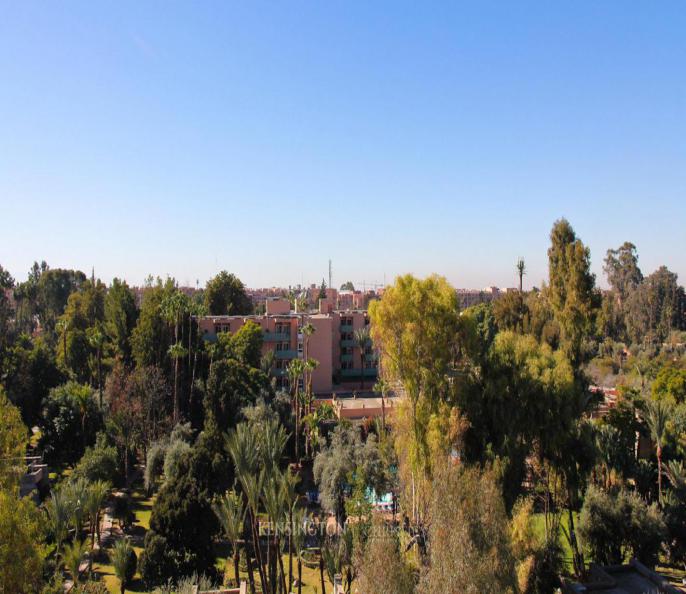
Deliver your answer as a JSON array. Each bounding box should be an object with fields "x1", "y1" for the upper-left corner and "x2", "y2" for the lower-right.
[{"x1": 197, "y1": 298, "x2": 378, "y2": 395}]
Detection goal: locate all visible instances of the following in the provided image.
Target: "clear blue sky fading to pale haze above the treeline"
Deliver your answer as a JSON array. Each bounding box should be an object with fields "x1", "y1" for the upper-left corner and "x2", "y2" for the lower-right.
[{"x1": 0, "y1": 0, "x2": 686, "y2": 287}]
